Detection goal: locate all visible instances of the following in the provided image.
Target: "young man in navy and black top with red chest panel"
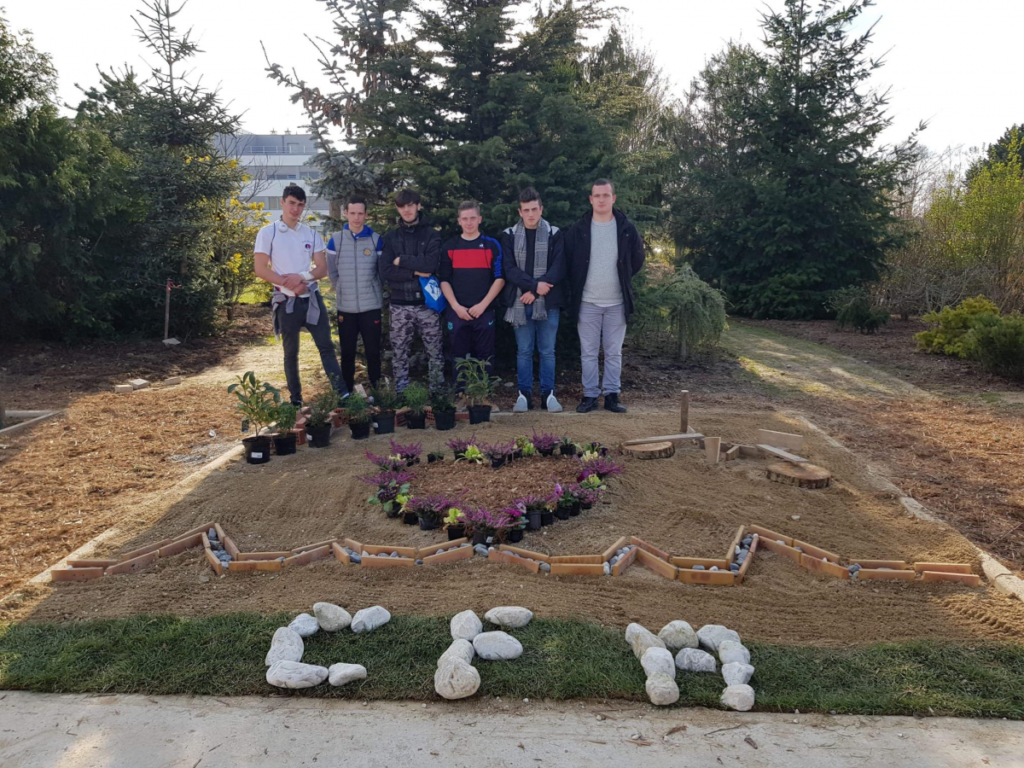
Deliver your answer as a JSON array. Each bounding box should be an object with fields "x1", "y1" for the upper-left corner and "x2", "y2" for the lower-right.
[{"x1": 437, "y1": 201, "x2": 505, "y2": 378}]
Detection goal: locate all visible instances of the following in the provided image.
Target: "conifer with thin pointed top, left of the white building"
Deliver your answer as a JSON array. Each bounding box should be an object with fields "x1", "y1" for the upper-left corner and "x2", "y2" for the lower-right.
[{"x1": 79, "y1": 0, "x2": 242, "y2": 334}]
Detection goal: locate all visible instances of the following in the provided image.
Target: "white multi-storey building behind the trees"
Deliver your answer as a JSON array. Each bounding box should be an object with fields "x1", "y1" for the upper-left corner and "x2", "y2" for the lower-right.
[{"x1": 217, "y1": 131, "x2": 330, "y2": 225}]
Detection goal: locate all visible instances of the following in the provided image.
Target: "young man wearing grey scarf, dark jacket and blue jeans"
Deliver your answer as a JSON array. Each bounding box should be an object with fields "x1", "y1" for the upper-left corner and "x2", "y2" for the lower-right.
[{"x1": 502, "y1": 187, "x2": 565, "y2": 413}]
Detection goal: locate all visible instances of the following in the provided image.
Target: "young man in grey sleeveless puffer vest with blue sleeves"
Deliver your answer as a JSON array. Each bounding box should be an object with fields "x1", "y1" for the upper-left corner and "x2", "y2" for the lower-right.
[{"x1": 327, "y1": 195, "x2": 384, "y2": 391}]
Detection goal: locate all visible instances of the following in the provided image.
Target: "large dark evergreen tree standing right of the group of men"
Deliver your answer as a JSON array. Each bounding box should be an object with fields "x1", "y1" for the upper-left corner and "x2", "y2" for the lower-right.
[{"x1": 673, "y1": 0, "x2": 914, "y2": 318}]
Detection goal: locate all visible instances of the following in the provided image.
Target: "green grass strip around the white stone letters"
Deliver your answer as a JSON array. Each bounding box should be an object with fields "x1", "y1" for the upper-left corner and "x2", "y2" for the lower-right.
[{"x1": 0, "y1": 613, "x2": 1024, "y2": 719}]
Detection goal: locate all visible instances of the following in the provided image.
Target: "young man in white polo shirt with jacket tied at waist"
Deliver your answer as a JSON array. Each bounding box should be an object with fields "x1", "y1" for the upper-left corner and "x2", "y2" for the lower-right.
[{"x1": 255, "y1": 184, "x2": 348, "y2": 406}]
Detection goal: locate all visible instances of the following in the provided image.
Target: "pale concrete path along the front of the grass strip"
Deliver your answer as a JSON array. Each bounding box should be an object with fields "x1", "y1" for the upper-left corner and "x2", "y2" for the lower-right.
[{"x1": 0, "y1": 691, "x2": 1024, "y2": 768}]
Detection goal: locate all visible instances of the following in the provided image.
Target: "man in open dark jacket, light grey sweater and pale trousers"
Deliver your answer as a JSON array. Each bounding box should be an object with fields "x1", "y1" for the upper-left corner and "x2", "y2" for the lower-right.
[{"x1": 565, "y1": 179, "x2": 644, "y2": 414}]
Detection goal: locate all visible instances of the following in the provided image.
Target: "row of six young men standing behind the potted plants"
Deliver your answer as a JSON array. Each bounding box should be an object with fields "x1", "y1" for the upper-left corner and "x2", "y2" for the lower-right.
[{"x1": 255, "y1": 179, "x2": 644, "y2": 413}]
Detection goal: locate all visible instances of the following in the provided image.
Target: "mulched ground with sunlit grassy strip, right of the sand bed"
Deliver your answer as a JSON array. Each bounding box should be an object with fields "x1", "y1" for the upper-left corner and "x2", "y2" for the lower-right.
[{"x1": 723, "y1": 323, "x2": 1024, "y2": 570}]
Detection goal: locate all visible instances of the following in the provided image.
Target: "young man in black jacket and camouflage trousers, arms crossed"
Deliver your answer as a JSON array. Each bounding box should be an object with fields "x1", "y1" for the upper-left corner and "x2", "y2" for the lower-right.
[{"x1": 378, "y1": 189, "x2": 444, "y2": 392}]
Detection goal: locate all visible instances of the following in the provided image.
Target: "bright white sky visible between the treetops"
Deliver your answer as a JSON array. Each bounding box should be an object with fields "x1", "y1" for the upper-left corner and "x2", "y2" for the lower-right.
[{"x1": 8, "y1": 0, "x2": 1024, "y2": 150}]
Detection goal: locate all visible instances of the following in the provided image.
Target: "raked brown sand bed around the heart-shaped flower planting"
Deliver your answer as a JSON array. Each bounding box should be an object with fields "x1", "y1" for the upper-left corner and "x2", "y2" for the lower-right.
[{"x1": 15, "y1": 411, "x2": 1024, "y2": 645}]
